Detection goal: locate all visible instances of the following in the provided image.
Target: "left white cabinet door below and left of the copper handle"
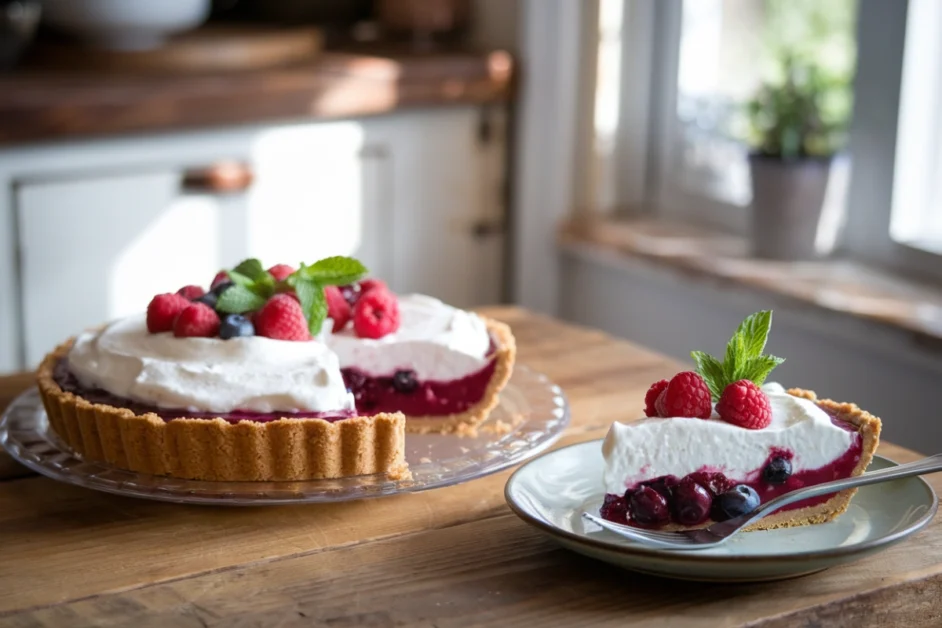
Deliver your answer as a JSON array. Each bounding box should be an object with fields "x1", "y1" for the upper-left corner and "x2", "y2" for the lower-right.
[{"x1": 16, "y1": 171, "x2": 224, "y2": 367}]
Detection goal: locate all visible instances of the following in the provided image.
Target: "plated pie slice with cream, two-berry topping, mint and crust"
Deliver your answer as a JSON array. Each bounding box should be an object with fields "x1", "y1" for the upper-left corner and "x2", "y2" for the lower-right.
[{"x1": 601, "y1": 311, "x2": 881, "y2": 530}]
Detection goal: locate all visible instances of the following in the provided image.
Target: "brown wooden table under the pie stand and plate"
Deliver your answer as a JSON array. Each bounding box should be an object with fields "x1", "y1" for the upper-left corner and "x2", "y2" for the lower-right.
[{"x1": 0, "y1": 308, "x2": 942, "y2": 627}]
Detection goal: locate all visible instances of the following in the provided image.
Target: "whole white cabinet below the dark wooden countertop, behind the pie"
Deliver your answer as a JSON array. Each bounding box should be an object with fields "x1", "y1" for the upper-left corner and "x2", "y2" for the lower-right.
[{"x1": 0, "y1": 107, "x2": 505, "y2": 370}]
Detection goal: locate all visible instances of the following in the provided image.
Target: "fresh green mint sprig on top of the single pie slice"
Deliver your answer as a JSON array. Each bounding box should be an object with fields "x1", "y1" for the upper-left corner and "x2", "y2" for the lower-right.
[{"x1": 690, "y1": 310, "x2": 785, "y2": 400}]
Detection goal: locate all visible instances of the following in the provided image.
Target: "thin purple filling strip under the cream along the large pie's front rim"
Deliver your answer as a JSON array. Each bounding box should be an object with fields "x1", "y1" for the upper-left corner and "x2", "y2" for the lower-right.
[{"x1": 53, "y1": 360, "x2": 357, "y2": 423}]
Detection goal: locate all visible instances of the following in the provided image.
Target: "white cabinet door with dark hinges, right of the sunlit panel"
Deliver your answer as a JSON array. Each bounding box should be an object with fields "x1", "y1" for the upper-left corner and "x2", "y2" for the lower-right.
[{"x1": 367, "y1": 108, "x2": 506, "y2": 307}]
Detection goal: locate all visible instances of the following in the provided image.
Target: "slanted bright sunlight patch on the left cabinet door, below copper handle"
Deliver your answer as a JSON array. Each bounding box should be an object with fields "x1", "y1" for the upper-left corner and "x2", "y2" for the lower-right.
[{"x1": 108, "y1": 196, "x2": 220, "y2": 319}]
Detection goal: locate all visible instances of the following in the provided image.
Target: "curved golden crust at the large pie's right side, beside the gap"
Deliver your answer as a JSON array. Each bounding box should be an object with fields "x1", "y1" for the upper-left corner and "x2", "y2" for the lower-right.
[{"x1": 406, "y1": 316, "x2": 517, "y2": 434}]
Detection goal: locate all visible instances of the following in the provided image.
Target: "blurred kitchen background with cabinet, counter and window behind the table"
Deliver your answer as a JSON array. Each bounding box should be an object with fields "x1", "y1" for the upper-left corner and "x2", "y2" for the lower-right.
[{"x1": 0, "y1": 0, "x2": 942, "y2": 452}]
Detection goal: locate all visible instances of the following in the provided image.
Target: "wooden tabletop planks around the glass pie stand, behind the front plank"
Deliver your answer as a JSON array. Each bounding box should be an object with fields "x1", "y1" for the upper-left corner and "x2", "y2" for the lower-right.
[{"x1": 0, "y1": 308, "x2": 677, "y2": 612}]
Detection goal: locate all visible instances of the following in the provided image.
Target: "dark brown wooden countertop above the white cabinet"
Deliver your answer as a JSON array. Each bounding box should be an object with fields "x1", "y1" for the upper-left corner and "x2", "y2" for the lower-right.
[{"x1": 0, "y1": 51, "x2": 513, "y2": 147}]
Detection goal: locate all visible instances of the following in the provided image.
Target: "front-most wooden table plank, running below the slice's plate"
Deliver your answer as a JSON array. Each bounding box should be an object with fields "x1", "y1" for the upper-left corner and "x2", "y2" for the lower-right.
[{"x1": 5, "y1": 462, "x2": 942, "y2": 627}]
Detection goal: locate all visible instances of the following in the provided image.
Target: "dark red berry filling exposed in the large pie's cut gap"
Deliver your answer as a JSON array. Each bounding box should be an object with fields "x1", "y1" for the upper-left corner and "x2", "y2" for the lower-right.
[{"x1": 341, "y1": 359, "x2": 497, "y2": 417}]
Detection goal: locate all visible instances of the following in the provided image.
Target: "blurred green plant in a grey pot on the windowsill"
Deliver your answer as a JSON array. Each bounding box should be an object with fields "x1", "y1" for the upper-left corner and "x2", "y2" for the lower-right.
[{"x1": 746, "y1": 53, "x2": 851, "y2": 260}]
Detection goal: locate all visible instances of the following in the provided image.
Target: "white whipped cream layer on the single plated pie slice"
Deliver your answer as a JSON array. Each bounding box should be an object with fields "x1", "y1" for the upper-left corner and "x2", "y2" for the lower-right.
[{"x1": 602, "y1": 384, "x2": 858, "y2": 494}]
